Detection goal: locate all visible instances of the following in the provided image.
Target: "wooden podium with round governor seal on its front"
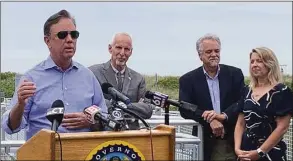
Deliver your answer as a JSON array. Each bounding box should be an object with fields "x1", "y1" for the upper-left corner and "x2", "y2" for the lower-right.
[{"x1": 17, "y1": 125, "x2": 175, "y2": 161}]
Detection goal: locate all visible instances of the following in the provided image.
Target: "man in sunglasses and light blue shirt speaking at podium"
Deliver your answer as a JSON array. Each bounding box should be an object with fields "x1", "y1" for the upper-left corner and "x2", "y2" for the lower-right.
[{"x1": 2, "y1": 10, "x2": 107, "y2": 140}]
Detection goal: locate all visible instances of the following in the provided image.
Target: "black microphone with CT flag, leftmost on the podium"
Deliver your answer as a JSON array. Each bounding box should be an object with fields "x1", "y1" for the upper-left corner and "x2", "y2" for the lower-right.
[{"x1": 46, "y1": 100, "x2": 64, "y2": 131}]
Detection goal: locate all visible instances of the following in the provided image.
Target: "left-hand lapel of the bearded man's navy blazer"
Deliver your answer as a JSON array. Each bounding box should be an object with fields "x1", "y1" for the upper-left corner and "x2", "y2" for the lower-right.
[{"x1": 198, "y1": 67, "x2": 214, "y2": 110}]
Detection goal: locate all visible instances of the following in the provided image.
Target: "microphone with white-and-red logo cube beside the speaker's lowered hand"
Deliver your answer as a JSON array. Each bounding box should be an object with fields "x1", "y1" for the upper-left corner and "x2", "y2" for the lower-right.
[{"x1": 83, "y1": 105, "x2": 121, "y2": 131}]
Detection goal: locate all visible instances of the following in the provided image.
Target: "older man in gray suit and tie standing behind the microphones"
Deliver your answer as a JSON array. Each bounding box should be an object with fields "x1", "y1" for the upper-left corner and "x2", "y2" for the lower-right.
[{"x1": 89, "y1": 33, "x2": 153, "y2": 129}]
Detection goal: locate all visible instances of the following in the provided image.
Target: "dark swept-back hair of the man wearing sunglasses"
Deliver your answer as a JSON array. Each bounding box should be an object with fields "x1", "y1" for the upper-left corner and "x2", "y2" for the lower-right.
[{"x1": 44, "y1": 10, "x2": 76, "y2": 36}]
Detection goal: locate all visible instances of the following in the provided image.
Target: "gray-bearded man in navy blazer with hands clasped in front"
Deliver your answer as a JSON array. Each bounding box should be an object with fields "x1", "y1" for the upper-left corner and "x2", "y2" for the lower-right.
[{"x1": 179, "y1": 34, "x2": 244, "y2": 161}]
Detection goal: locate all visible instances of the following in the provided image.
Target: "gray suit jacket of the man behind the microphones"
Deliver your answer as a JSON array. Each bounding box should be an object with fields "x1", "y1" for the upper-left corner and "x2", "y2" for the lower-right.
[{"x1": 89, "y1": 61, "x2": 154, "y2": 129}]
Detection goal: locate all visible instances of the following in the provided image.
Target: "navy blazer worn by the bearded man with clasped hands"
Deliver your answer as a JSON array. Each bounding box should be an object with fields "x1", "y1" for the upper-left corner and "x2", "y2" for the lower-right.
[{"x1": 179, "y1": 64, "x2": 245, "y2": 160}]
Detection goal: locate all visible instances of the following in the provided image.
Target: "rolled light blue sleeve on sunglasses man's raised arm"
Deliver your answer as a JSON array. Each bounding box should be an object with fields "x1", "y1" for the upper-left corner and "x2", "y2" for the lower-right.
[{"x1": 2, "y1": 77, "x2": 32, "y2": 135}]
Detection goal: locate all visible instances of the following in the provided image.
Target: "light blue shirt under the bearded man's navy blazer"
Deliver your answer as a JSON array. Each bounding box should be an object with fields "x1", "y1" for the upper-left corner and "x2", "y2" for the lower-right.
[{"x1": 203, "y1": 67, "x2": 221, "y2": 114}]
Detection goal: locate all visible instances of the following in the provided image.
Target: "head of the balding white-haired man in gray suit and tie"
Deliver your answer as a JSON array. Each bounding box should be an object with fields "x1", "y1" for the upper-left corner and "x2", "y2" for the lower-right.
[{"x1": 108, "y1": 33, "x2": 132, "y2": 71}]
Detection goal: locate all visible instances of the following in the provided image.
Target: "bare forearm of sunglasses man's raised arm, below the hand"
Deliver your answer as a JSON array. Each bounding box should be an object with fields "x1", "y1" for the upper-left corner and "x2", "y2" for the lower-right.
[{"x1": 8, "y1": 103, "x2": 25, "y2": 131}]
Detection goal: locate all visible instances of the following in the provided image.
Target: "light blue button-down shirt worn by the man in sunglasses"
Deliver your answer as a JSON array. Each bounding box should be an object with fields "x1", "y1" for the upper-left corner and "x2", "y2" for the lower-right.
[{"x1": 2, "y1": 56, "x2": 108, "y2": 140}]
